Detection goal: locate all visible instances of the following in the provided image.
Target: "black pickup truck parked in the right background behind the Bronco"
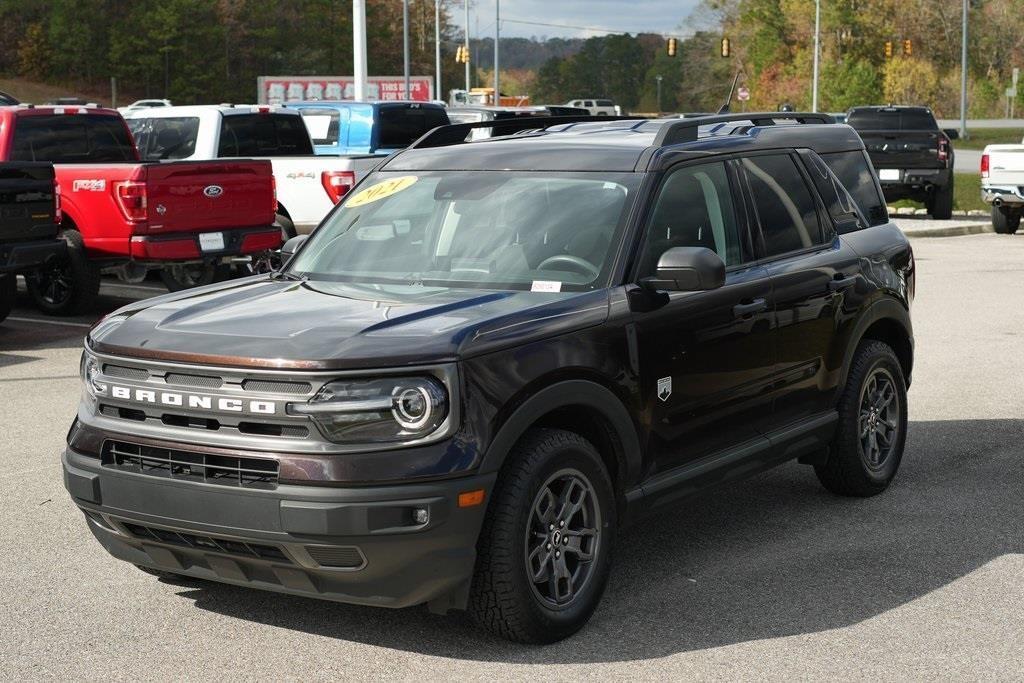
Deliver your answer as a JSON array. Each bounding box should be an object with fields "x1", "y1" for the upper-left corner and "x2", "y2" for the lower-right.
[{"x1": 846, "y1": 106, "x2": 957, "y2": 219}]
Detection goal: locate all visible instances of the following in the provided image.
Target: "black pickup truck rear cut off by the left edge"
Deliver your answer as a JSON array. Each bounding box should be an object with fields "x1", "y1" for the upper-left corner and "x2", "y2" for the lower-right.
[{"x1": 0, "y1": 162, "x2": 66, "y2": 321}]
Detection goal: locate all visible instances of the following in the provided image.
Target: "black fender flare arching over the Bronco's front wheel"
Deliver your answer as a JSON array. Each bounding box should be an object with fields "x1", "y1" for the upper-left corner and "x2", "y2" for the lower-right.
[{"x1": 479, "y1": 380, "x2": 641, "y2": 490}]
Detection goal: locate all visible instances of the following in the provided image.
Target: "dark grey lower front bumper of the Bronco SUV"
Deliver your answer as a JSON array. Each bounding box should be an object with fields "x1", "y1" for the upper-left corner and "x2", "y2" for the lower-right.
[{"x1": 61, "y1": 449, "x2": 495, "y2": 608}]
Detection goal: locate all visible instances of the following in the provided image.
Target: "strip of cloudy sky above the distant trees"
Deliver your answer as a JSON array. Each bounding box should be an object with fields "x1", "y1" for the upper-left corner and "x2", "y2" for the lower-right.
[{"x1": 452, "y1": 0, "x2": 699, "y2": 38}]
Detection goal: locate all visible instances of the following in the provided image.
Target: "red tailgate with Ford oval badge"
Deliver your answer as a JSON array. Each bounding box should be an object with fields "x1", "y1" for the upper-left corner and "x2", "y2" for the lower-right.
[{"x1": 142, "y1": 159, "x2": 275, "y2": 232}]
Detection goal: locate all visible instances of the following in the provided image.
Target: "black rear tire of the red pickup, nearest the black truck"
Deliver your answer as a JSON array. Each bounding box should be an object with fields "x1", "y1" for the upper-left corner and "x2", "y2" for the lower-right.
[{"x1": 25, "y1": 229, "x2": 99, "y2": 315}]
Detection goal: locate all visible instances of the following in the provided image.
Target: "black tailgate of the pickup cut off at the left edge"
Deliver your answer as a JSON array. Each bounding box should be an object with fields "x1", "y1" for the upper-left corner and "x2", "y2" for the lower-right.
[{"x1": 0, "y1": 162, "x2": 57, "y2": 242}]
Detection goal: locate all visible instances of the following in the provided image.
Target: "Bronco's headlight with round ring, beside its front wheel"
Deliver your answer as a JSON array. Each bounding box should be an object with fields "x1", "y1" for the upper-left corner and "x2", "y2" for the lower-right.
[{"x1": 288, "y1": 377, "x2": 449, "y2": 443}]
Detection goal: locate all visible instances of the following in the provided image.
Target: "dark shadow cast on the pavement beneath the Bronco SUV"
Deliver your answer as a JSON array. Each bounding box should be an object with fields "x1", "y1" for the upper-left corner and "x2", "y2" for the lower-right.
[{"x1": 172, "y1": 420, "x2": 1024, "y2": 664}]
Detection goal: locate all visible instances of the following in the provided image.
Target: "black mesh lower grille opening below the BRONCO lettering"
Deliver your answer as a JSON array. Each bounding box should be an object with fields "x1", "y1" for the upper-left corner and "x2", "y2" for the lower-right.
[{"x1": 101, "y1": 441, "x2": 278, "y2": 488}]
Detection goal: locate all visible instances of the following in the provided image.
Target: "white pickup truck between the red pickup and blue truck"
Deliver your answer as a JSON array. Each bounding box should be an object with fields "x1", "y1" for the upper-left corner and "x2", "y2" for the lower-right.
[{"x1": 125, "y1": 104, "x2": 384, "y2": 240}]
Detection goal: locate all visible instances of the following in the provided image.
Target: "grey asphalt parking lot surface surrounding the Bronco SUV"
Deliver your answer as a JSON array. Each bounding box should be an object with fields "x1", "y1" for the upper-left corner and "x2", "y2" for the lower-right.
[{"x1": 0, "y1": 234, "x2": 1024, "y2": 680}]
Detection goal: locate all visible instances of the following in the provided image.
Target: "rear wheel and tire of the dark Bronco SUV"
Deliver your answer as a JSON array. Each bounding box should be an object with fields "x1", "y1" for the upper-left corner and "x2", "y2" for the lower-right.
[{"x1": 814, "y1": 339, "x2": 906, "y2": 498}]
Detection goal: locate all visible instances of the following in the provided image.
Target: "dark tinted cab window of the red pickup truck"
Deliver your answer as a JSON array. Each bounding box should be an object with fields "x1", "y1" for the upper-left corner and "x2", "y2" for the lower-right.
[{"x1": 10, "y1": 114, "x2": 135, "y2": 164}]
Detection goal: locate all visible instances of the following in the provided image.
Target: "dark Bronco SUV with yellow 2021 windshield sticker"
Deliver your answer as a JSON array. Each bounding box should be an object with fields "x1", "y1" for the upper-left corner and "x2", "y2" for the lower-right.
[{"x1": 62, "y1": 113, "x2": 914, "y2": 642}]
